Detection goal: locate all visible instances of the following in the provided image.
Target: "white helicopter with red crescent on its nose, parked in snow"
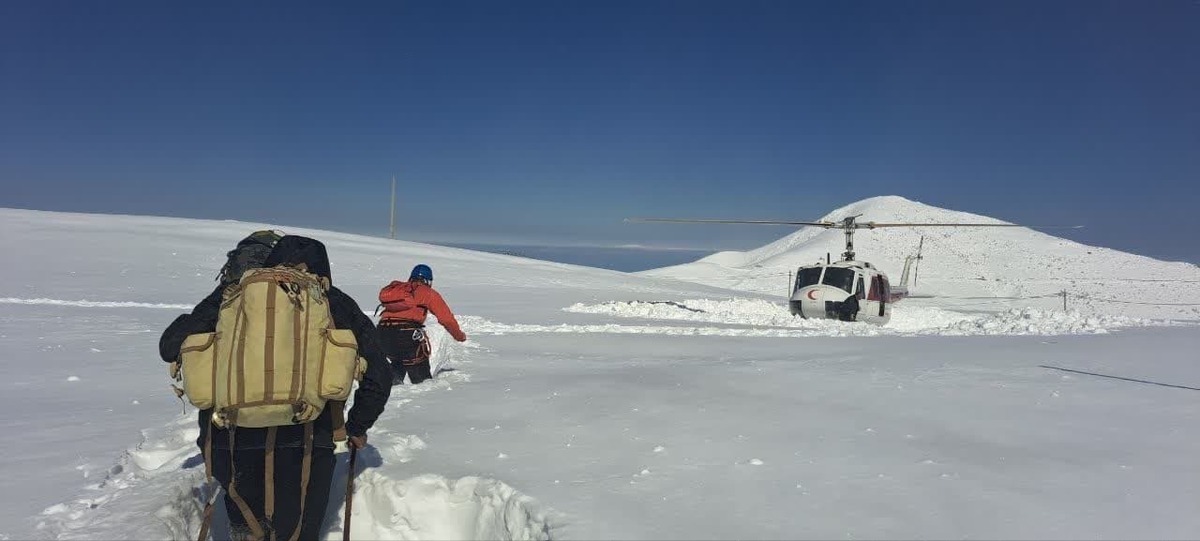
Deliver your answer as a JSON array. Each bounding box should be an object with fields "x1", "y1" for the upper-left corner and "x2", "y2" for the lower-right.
[{"x1": 625, "y1": 215, "x2": 1082, "y2": 325}]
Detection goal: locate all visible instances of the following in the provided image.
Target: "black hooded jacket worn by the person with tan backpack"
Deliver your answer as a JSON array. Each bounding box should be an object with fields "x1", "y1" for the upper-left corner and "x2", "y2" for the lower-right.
[{"x1": 158, "y1": 235, "x2": 391, "y2": 449}]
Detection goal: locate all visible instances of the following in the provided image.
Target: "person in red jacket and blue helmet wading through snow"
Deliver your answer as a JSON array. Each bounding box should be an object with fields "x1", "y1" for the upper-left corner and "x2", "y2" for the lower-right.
[{"x1": 378, "y1": 265, "x2": 467, "y2": 385}]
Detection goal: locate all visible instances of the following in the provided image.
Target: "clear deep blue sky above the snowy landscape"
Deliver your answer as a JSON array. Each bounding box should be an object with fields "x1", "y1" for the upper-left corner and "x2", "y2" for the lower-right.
[{"x1": 0, "y1": 0, "x2": 1200, "y2": 262}]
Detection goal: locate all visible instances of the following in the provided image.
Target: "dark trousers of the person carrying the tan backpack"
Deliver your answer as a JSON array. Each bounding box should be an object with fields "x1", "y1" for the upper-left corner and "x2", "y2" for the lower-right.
[{"x1": 212, "y1": 447, "x2": 334, "y2": 541}]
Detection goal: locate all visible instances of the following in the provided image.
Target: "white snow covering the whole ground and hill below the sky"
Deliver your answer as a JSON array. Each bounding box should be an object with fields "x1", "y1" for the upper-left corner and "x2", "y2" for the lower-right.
[{"x1": 0, "y1": 205, "x2": 1200, "y2": 539}]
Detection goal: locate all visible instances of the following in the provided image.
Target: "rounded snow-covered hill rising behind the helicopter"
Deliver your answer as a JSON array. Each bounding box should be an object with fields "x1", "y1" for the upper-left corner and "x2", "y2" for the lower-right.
[{"x1": 641, "y1": 196, "x2": 1200, "y2": 319}]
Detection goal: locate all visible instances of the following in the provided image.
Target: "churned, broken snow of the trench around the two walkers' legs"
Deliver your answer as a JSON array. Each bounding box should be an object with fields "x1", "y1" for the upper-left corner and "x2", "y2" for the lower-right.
[{"x1": 37, "y1": 333, "x2": 551, "y2": 540}]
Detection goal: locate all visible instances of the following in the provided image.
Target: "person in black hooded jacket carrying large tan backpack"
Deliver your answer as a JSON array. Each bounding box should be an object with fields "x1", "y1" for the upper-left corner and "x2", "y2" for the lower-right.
[{"x1": 160, "y1": 235, "x2": 391, "y2": 540}]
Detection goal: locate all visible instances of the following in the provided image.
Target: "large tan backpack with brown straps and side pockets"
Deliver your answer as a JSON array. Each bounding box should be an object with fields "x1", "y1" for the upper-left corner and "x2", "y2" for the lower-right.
[{"x1": 172, "y1": 266, "x2": 366, "y2": 428}]
